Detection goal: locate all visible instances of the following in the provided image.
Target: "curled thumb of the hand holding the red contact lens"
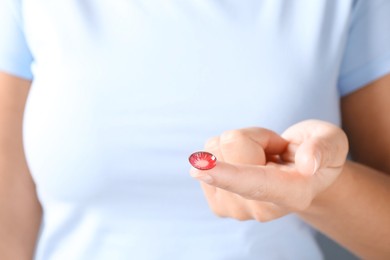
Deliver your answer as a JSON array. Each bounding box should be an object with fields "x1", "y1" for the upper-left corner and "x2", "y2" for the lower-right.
[{"x1": 282, "y1": 120, "x2": 348, "y2": 175}]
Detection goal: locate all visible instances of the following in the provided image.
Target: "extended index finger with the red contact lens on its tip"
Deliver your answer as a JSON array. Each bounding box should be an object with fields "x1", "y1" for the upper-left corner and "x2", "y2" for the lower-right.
[{"x1": 190, "y1": 161, "x2": 310, "y2": 207}]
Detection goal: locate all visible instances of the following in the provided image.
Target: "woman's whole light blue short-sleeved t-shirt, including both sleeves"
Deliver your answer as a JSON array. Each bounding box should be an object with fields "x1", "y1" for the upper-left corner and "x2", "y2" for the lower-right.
[{"x1": 0, "y1": 0, "x2": 390, "y2": 260}]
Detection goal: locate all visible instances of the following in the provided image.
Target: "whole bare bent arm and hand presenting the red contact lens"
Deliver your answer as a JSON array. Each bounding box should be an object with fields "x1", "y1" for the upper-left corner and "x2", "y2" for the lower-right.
[{"x1": 190, "y1": 75, "x2": 390, "y2": 259}]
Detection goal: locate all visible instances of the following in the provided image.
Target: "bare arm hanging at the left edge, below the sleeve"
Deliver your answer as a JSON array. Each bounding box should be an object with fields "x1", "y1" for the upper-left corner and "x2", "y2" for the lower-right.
[{"x1": 0, "y1": 73, "x2": 41, "y2": 260}]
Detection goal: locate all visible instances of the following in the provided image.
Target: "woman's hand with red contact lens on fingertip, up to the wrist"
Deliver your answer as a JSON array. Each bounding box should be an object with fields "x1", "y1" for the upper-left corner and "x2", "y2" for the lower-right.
[{"x1": 190, "y1": 120, "x2": 348, "y2": 222}]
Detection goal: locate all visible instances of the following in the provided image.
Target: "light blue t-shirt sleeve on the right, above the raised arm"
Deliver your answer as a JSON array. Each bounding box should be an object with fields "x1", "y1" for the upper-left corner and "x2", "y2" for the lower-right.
[{"x1": 338, "y1": 0, "x2": 390, "y2": 96}]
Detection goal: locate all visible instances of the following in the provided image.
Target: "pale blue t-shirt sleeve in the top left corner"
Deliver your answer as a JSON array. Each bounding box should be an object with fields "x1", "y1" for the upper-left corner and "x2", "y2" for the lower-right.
[{"x1": 0, "y1": 0, "x2": 33, "y2": 79}]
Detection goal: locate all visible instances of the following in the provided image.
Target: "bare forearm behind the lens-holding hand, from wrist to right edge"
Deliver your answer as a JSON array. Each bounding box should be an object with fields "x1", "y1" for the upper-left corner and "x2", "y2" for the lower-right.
[{"x1": 300, "y1": 162, "x2": 390, "y2": 259}]
